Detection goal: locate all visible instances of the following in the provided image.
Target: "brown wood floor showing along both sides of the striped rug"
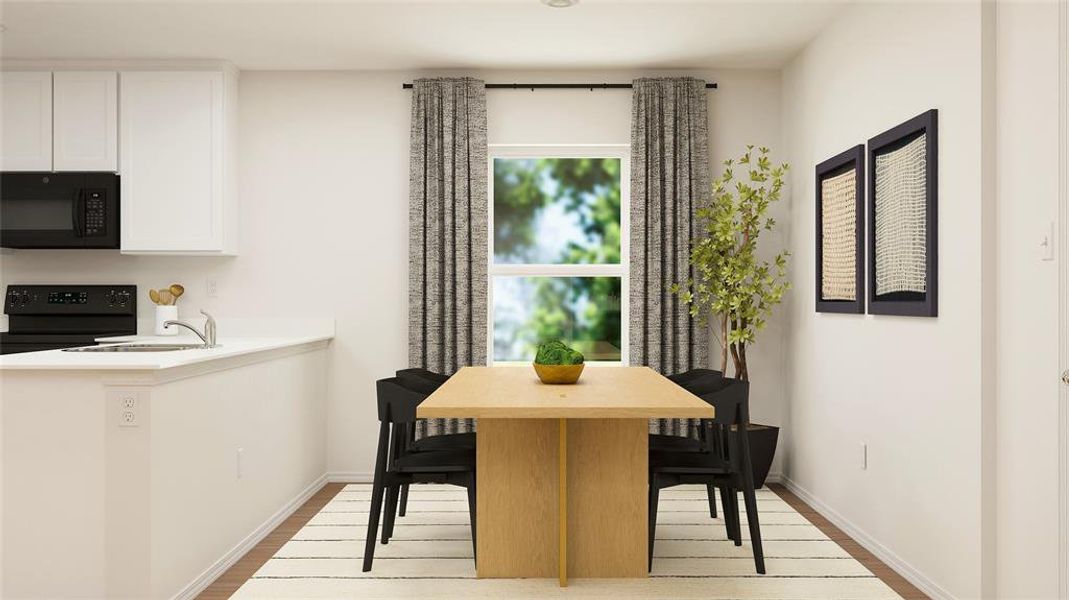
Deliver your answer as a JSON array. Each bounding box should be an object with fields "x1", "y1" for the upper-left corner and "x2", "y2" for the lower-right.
[{"x1": 198, "y1": 483, "x2": 928, "y2": 600}]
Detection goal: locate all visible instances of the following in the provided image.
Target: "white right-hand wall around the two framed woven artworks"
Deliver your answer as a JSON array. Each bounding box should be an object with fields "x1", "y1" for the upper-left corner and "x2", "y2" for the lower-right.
[{"x1": 783, "y1": 2, "x2": 993, "y2": 598}]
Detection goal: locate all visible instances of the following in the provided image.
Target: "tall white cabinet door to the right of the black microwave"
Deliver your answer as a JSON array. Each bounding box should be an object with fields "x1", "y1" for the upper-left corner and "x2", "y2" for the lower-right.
[{"x1": 119, "y1": 71, "x2": 236, "y2": 255}]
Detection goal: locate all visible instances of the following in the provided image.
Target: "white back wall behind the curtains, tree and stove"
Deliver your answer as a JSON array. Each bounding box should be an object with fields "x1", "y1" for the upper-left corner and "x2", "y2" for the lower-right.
[{"x1": 0, "y1": 66, "x2": 786, "y2": 476}]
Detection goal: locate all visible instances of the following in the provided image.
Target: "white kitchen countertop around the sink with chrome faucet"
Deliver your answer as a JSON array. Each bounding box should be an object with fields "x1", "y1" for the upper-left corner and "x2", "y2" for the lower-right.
[{"x1": 0, "y1": 319, "x2": 334, "y2": 371}]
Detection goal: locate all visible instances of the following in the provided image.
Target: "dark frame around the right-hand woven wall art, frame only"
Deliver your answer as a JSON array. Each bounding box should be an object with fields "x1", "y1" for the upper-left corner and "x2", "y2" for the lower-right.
[{"x1": 867, "y1": 109, "x2": 939, "y2": 317}]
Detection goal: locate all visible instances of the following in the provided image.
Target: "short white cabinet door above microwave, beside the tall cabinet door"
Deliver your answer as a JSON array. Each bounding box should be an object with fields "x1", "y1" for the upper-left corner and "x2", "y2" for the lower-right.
[{"x1": 52, "y1": 71, "x2": 119, "y2": 171}]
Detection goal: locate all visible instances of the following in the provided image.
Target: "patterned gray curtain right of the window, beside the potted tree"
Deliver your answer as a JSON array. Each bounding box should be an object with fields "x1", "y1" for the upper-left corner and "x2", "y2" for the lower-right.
[{"x1": 630, "y1": 77, "x2": 710, "y2": 435}]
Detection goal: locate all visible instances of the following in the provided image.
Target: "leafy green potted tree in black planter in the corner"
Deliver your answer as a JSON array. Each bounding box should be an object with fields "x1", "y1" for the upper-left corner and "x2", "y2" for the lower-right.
[{"x1": 672, "y1": 145, "x2": 790, "y2": 487}]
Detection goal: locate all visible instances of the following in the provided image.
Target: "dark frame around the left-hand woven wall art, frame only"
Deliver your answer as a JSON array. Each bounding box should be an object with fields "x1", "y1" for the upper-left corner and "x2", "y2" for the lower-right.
[{"x1": 814, "y1": 144, "x2": 866, "y2": 314}]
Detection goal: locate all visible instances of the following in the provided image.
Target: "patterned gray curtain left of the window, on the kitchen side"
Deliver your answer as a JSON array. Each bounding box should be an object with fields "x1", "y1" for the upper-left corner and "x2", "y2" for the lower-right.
[{"x1": 408, "y1": 78, "x2": 487, "y2": 436}]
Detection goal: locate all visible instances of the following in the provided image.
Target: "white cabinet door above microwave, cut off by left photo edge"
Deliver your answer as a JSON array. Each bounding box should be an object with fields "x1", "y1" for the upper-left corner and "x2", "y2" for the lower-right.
[{"x1": 0, "y1": 71, "x2": 52, "y2": 171}]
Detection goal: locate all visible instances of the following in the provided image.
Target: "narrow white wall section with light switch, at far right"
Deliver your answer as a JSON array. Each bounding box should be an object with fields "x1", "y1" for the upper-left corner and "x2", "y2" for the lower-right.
[{"x1": 996, "y1": 1, "x2": 1066, "y2": 599}]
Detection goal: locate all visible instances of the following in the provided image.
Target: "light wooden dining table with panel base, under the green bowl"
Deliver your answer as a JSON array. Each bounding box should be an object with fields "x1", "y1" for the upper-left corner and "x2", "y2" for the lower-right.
[{"x1": 417, "y1": 366, "x2": 713, "y2": 586}]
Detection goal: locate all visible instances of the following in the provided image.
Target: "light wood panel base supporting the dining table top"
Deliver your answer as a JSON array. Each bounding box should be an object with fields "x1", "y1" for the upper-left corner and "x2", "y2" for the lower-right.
[{"x1": 476, "y1": 418, "x2": 648, "y2": 586}]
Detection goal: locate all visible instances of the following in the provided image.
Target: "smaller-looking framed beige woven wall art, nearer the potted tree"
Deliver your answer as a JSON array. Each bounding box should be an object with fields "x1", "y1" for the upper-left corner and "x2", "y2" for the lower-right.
[{"x1": 815, "y1": 145, "x2": 865, "y2": 314}]
